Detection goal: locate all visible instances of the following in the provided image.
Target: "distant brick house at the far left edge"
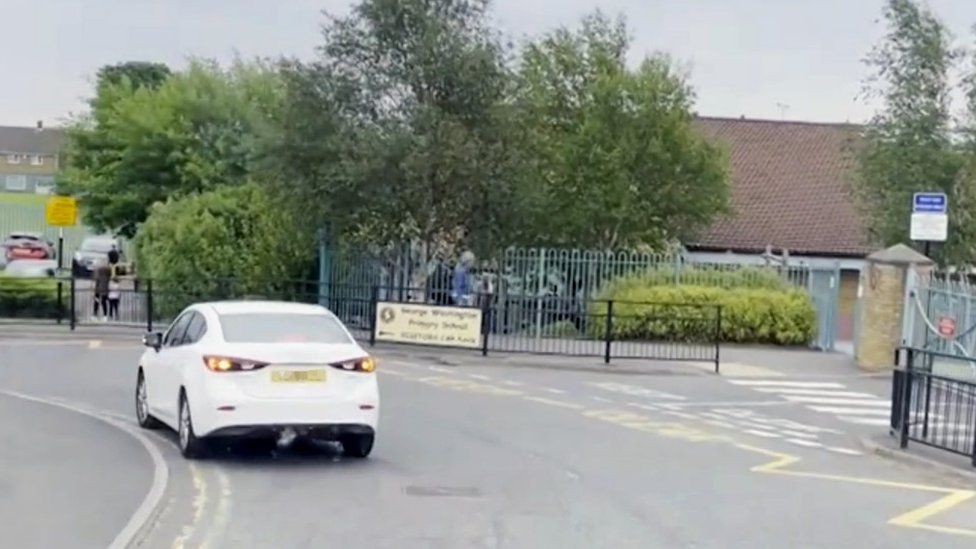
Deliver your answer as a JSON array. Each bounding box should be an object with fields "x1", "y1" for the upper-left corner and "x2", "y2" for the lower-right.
[{"x1": 0, "y1": 122, "x2": 64, "y2": 194}]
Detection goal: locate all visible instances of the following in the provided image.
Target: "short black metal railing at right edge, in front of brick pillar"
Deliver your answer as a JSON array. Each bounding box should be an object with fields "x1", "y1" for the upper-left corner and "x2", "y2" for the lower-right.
[{"x1": 891, "y1": 348, "x2": 976, "y2": 466}]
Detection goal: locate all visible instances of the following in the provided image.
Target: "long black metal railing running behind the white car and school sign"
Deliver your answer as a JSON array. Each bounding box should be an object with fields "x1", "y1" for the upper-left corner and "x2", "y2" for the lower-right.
[{"x1": 0, "y1": 278, "x2": 722, "y2": 372}]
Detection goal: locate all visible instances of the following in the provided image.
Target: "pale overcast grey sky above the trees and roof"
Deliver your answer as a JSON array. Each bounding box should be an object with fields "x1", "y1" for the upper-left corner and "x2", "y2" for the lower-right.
[{"x1": 0, "y1": 0, "x2": 976, "y2": 126}]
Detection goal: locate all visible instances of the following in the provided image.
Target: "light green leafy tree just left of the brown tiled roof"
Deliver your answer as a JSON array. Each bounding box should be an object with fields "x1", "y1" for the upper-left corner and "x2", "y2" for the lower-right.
[{"x1": 516, "y1": 12, "x2": 728, "y2": 249}]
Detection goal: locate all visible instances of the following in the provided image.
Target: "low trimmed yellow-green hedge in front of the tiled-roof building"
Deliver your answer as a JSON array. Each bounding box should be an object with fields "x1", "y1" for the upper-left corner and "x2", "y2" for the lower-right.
[{"x1": 590, "y1": 282, "x2": 816, "y2": 345}]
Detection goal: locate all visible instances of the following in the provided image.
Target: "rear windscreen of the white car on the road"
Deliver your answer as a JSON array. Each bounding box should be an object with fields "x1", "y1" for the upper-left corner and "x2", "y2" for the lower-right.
[{"x1": 220, "y1": 313, "x2": 352, "y2": 343}]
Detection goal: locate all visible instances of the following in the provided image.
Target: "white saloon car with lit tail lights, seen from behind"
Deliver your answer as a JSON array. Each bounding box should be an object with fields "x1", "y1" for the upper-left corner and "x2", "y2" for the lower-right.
[{"x1": 136, "y1": 301, "x2": 380, "y2": 458}]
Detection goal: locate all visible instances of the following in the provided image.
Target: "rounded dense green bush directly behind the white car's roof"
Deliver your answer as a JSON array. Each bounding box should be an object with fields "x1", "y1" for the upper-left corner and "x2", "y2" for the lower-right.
[{"x1": 135, "y1": 184, "x2": 313, "y2": 298}]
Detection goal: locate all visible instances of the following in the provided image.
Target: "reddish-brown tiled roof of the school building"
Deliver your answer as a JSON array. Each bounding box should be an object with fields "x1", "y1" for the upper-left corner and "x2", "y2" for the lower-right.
[{"x1": 686, "y1": 118, "x2": 873, "y2": 256}]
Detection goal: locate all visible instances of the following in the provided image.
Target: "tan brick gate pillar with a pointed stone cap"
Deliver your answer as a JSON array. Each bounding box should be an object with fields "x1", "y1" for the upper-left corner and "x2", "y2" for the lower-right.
[{"x1": 855, "y1": 244, "x2": 933, "y2": 371}]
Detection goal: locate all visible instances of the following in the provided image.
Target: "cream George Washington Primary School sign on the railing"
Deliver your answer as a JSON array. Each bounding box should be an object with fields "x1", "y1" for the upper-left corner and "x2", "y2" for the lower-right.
[{"x1": 375, "y1": 301, "x2": 481, "y2": 349}]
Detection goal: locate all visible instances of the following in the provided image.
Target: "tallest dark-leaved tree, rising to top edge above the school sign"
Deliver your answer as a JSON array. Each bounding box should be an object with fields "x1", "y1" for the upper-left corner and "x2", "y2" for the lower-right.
[{"x1": 273, "y1": 0, "x2": 528, "y2": 256}]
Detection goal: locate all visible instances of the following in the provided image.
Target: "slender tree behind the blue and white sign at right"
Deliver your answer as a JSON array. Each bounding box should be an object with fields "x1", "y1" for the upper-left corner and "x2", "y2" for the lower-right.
[{"x1": 854, "y1": 0, "x2": 960, "y2": 261}]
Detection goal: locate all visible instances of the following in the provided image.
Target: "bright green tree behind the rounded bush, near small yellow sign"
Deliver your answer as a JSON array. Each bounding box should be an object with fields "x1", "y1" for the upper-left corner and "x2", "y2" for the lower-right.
[{"x1": 59, "y1": 61, "x2": 283, "y2": 237}]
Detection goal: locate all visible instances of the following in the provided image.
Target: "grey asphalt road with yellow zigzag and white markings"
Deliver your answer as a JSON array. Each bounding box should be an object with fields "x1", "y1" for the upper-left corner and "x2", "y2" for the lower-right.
[{"x1": 0, "y1": 337, "x2": 976, "y2": 548}]
